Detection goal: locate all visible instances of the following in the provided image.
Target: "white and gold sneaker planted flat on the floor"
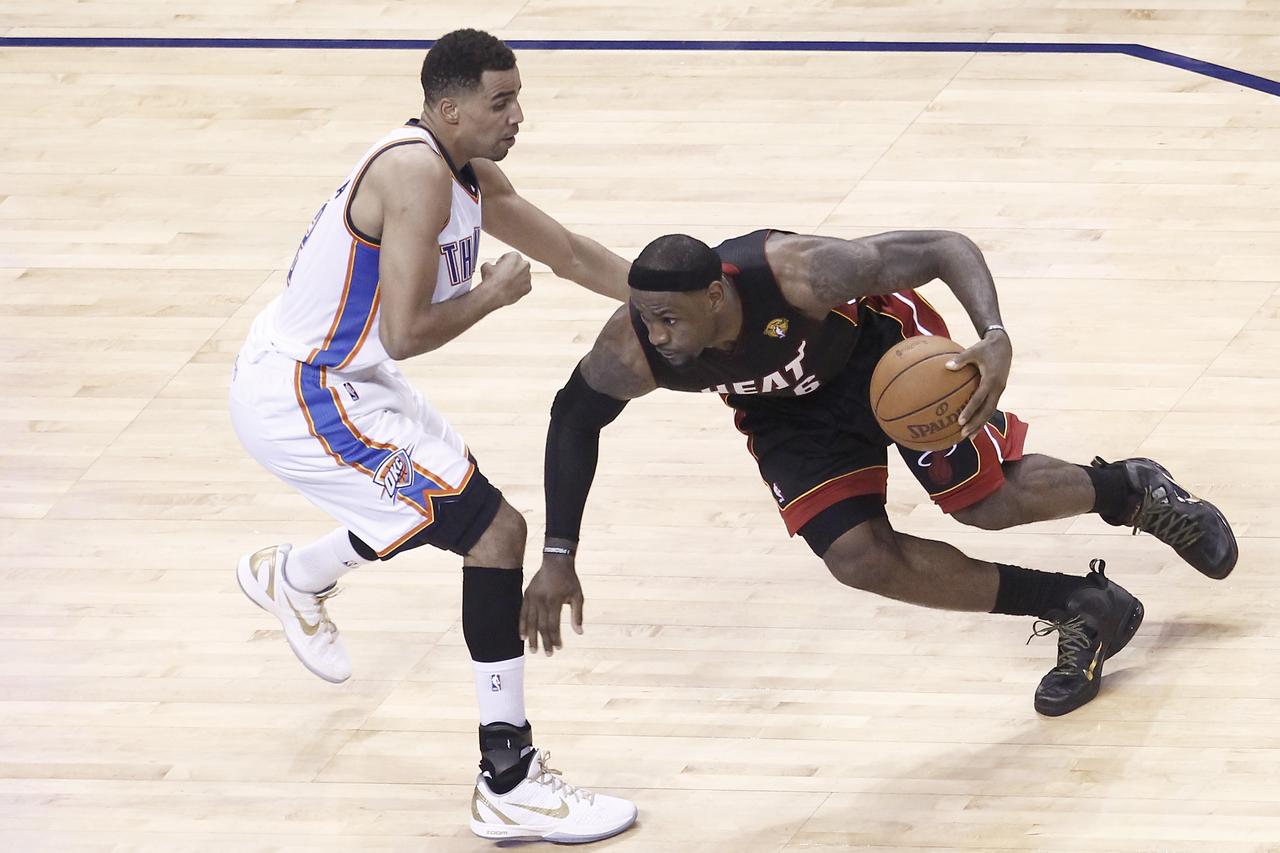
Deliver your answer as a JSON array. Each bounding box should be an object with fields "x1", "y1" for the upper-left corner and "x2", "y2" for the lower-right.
[{"x1": 471, "y1": 751, "x2": 636, "y2": 844}]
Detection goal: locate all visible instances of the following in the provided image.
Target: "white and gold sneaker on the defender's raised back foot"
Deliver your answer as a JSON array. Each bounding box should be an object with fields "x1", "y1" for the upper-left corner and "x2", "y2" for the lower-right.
[{"x1": 236, "y1": 544, "x2": 351, "y2": 684}]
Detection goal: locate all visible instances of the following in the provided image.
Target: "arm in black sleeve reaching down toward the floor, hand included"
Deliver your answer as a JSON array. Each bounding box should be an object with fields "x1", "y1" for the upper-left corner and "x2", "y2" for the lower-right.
[{"x1": 520, "y1": 305, "x2": 657, "y2": 656}]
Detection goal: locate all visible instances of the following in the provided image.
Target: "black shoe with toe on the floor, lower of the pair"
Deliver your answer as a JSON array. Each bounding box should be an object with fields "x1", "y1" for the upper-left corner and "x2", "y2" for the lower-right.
[{"x1": 1027, "y1": 560, "x2": 1143, "y2": 717}]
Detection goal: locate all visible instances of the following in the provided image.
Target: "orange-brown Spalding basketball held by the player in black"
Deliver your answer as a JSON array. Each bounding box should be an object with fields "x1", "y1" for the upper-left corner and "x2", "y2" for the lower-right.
[{"x1": 870, "y1": 336, "x2": 980, "y2": 451}]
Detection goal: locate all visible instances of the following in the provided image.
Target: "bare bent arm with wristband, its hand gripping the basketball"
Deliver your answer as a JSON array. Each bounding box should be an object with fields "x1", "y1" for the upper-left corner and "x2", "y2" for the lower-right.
[{"x1": 768, "y1": 231, "x2": 1014, "y2": 438}]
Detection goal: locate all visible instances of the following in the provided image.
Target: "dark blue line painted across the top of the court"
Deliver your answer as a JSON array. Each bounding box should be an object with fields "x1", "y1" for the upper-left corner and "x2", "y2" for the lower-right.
[{"x1": 0, "y1": 36, "x2": 1280, "y2": 95}]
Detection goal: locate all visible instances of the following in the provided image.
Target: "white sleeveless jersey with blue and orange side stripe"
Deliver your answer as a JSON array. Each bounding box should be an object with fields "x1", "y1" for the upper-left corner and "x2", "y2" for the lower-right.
[{"x1": 251, "y1": 119, "x2": 480, "y2": 370}]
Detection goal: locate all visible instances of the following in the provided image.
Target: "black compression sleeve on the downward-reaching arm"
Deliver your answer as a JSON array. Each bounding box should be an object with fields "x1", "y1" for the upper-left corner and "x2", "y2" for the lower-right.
[{"x1": 543, "y1": 366, "x2": 627, "y2": 542}]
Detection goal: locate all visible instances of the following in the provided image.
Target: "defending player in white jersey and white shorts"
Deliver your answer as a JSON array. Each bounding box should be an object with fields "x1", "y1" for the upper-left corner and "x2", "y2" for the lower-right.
[{"x1": 230, "y1": 29, "x2": 636, "y2": 841}]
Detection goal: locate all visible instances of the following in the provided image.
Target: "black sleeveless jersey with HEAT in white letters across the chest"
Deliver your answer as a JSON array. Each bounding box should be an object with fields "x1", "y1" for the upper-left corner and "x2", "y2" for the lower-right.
[{"x1": 631, "y1": 229, "x2": 859, "y2": 402}]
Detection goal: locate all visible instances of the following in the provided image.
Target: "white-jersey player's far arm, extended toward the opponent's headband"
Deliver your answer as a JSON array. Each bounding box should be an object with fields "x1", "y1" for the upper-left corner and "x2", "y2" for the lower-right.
[{"x1": 471, "y1": 160, "x2": 631, "y2": 302}]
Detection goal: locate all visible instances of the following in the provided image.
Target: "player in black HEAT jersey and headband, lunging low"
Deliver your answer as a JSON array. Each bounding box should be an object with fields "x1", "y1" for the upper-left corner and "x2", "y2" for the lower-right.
[{"x1": 521, "y1": 225, "x2": 1236, "y2": 716}]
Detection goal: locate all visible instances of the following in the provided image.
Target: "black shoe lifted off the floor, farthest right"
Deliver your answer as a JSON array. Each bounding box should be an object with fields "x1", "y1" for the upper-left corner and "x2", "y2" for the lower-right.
[{"x1": 1093, "y1": 457, "x2": 1240, "y2": 580}]
